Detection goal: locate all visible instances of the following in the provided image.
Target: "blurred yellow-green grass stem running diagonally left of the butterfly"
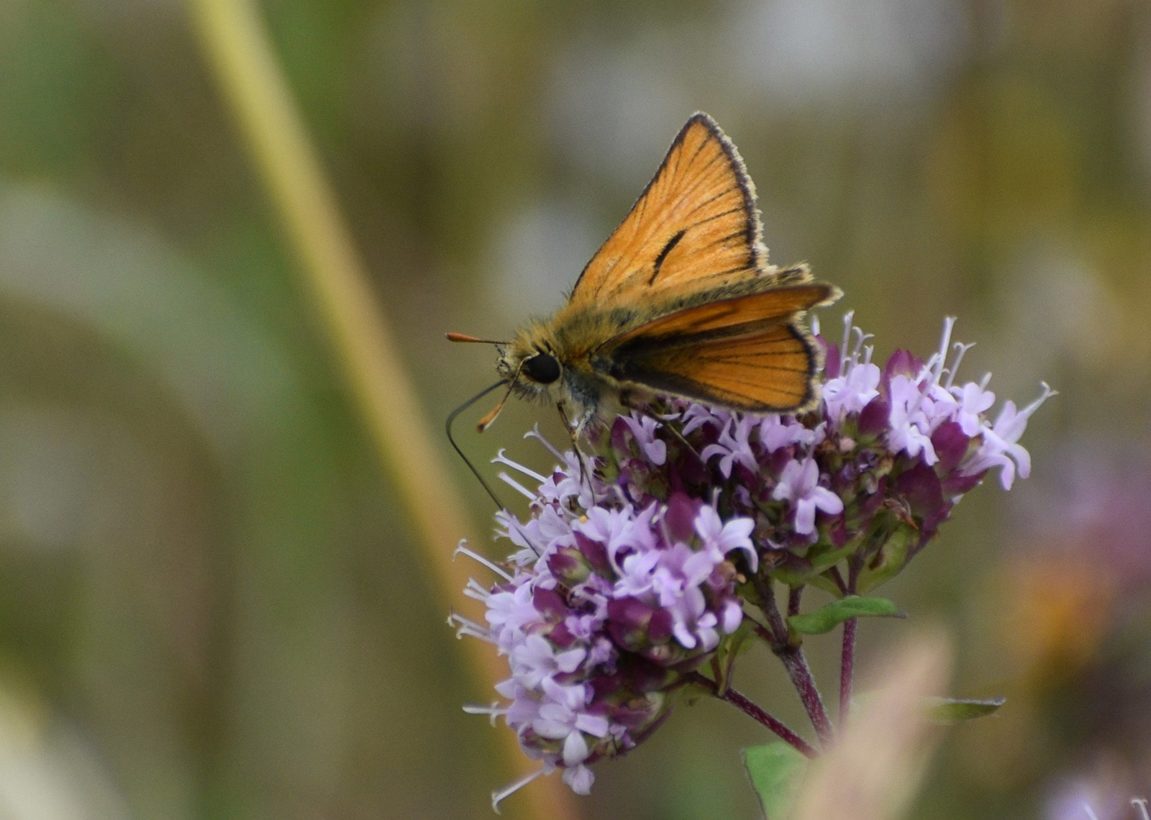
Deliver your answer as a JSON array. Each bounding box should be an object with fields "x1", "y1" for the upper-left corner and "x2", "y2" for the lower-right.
[{"x1": 190, "y1": 0, "x2": 576, "y2": 818}]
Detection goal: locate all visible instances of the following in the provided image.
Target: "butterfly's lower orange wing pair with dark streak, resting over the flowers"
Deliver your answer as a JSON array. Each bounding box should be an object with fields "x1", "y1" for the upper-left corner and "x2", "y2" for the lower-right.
[{"x1": 597, "y1": 284, "x2": 838, "y2": 412}]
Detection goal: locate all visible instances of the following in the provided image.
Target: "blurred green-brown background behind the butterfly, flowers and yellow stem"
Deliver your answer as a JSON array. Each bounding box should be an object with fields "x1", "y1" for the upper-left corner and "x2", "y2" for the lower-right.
[{"x1": 0, "y1": 0, "x2": 1151, "y2": 818}]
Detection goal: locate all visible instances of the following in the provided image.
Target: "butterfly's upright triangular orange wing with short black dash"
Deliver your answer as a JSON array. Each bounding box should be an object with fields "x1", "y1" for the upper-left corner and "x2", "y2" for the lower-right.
[{"x1": 569, "y1": 113, "x2": 767, "y2": 306}]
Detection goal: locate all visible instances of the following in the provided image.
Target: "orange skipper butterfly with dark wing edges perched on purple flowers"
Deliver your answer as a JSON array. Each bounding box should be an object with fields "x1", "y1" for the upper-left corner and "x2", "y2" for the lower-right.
[{"x1": 448, "y1": 113, "x2": 840, "y2": 436}]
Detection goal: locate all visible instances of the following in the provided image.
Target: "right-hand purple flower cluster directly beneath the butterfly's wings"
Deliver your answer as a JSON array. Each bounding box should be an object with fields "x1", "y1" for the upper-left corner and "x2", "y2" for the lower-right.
[{"x1": 584, "y1": 316, "x2": 1052, "y2": 595}]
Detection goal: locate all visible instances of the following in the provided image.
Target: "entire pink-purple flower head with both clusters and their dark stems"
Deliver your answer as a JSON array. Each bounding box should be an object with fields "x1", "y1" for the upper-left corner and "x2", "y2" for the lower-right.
[{"x1": 453, "y1": 314, "x2": 1053, "y2": 803}]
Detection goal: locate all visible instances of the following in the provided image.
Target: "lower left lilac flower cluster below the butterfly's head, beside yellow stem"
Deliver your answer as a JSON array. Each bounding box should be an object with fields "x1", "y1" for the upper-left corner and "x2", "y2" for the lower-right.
[{"x1": 456, "y1": 454, "x2": 756, "y2": 802}]
